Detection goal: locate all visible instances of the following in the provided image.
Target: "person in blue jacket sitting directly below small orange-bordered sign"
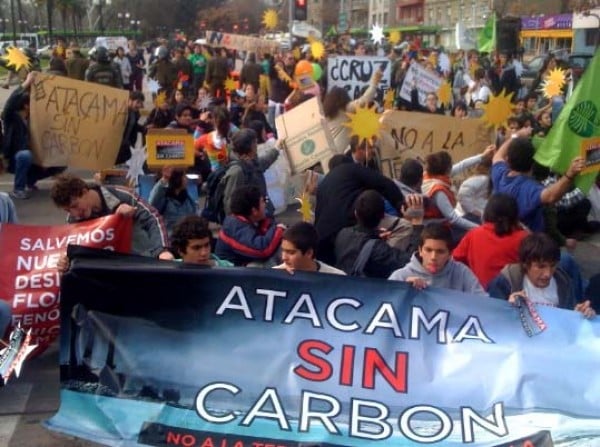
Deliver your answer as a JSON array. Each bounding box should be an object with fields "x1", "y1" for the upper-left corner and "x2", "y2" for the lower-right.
[{"x1": 148, "y1": 166, "x2": 198, "y2": 234}]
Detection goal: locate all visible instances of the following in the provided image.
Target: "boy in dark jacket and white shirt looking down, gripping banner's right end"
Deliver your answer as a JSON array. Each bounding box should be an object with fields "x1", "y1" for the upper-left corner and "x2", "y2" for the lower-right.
[{"x1": 488, "y1": 233, "x2": 596, "y2": 318}]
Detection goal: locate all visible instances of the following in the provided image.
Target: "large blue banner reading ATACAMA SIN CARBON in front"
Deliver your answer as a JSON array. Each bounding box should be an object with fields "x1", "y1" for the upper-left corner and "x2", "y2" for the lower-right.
[{"x1": 47, "y1": 249, "x2": 600, "y2": 447}]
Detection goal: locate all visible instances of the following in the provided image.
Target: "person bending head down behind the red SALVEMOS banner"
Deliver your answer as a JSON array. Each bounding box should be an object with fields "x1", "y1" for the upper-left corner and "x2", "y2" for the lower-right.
[{"x1": 50, "y1": 174, "x2": 173, "y2": 259}]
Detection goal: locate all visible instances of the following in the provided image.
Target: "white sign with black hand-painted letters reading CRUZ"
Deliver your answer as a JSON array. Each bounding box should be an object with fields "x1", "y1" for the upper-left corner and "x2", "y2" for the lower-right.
[{"x1": 327, "y1": 56, "x2": 391, "y2": 105}]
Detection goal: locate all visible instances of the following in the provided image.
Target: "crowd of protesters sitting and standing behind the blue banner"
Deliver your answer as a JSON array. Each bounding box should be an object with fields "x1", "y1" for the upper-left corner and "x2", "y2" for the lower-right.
[{"x1": 0, "y1": 31, "x2": 600, "y2": 334}]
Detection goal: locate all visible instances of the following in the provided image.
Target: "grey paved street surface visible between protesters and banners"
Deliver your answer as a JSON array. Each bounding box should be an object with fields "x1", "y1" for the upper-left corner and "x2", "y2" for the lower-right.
[{"x1": 0, "y1": 80, "x2": 600, "y2": 447}]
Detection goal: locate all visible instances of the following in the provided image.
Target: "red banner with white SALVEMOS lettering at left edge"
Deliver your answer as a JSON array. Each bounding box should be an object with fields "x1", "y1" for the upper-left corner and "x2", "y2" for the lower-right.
[{"x1": 0, "y1": 215, "x2": 131, "y2": 354}]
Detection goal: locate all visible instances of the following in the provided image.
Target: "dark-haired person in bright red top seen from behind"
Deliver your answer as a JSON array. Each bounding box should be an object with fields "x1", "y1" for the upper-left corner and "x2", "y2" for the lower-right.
[{"x1": 452, "y1": 194, "x2": 529, "y2": 288}]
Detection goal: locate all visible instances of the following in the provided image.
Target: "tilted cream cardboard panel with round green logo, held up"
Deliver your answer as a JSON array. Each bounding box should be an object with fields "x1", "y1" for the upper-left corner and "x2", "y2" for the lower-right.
[{"x1": 275, "y1": 97, "x2": 335, "y2": 174}]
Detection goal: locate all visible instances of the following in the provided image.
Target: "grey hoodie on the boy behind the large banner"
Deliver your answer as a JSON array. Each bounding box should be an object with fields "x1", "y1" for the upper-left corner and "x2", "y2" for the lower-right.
[{"x1": 388, "y1": 253, "x2": 487, "y2": 296}]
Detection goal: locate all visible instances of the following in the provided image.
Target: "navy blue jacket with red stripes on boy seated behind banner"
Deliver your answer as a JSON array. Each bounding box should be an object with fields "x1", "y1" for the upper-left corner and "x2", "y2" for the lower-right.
[{"x1": 215, "y1": 215, "x2": 283, "y2": 266}]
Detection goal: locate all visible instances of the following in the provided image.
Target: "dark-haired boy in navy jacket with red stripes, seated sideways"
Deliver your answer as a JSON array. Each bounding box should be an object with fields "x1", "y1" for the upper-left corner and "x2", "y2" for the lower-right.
[{"x1": 215, "y1": 185, "x2": 283, "y2": 267}]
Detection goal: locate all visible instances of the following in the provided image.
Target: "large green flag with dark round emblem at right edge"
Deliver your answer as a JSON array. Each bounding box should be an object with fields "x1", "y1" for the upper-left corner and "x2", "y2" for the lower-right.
[{"x1": 535, "y1": 51, "x2": 600, "y2": 192}]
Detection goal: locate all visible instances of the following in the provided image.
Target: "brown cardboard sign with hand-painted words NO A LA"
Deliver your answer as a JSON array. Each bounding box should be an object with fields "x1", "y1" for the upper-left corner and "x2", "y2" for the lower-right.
[{"x1": 380, "y1": 111, "x2": 493, "y2": 179}]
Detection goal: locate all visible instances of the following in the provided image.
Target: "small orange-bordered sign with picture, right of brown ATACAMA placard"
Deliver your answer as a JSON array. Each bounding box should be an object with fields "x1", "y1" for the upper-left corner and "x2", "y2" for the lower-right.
[{"x1": 146, "y1": 129, "x2": 194, "y2": 167}]
